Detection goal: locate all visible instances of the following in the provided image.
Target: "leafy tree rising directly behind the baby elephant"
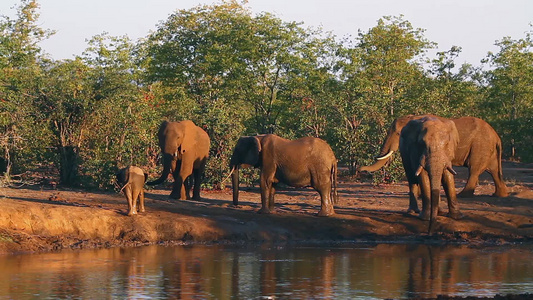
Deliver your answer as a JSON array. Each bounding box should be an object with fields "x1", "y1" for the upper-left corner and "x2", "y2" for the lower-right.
[{"x1": 81, "y1": 33, "x2": 160, "y2": 187}]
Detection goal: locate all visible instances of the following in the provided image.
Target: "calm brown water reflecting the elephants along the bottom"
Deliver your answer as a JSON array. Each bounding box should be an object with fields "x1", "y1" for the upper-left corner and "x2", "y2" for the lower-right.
[{"x1": 0, "y1": 244, "x2": 533, "y2": 299}]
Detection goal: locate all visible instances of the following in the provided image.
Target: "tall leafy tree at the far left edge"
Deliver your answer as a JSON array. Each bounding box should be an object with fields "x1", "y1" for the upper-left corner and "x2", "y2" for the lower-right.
[{"x1": 0, "y1": 0, "x2": 53, "y2": 183}]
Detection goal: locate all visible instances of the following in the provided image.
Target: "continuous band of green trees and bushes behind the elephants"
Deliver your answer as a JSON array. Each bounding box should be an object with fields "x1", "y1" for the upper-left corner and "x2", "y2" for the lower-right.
[{"x1": 0, "y1": 0, "x2": 533, "y2": 188}]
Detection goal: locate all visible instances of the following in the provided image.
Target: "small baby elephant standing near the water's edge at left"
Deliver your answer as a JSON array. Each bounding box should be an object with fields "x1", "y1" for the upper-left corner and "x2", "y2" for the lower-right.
[{"x1": 116, "y1": 166, "x2": 148, "y2": 216}]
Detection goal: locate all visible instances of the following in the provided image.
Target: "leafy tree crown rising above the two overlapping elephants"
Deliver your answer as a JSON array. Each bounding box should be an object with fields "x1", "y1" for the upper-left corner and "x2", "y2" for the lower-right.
[{"x1": 356, "y1": 16, "x2": 434, "y2": 117}]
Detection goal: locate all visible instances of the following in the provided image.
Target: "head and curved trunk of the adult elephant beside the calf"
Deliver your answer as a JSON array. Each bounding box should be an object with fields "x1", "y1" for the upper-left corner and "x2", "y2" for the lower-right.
[{"x1": 147, "y1": 121, "x2": 196, "y2": 185}]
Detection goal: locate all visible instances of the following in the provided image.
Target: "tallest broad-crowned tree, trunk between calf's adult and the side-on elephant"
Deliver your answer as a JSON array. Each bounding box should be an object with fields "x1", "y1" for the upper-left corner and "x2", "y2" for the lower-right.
[{"x1": 144, "y1": 1, "x2": 253, "y2": 185}]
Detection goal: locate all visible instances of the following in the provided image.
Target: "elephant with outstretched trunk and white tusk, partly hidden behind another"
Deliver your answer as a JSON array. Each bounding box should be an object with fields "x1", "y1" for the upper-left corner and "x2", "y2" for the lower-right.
[{"x1": 360, "y1": 115, "x2": 509, "y2": 203}]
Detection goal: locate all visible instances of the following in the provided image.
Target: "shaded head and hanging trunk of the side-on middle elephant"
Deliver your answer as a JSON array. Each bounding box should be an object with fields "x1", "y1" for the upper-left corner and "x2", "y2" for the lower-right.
[{"x1": 229, "y1": 136, "x2": 262, "y2": 205}]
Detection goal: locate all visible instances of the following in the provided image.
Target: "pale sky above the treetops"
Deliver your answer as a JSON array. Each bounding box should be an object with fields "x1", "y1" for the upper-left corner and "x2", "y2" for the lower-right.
[{"x1": 0, "y1": 0, "x2": 533, "y2": 65}]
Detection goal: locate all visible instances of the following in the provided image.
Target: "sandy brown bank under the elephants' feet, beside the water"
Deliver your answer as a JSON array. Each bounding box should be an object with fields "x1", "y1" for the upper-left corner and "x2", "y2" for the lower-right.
[{"x1": 0, "y1": 162, "x2": 533, "y2": 254}]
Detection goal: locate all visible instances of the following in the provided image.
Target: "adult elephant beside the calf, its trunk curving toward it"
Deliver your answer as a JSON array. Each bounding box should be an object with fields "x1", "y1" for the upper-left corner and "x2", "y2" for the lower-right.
[{"x1": 146, "y1": 120, "x2": 211, "y2": 200}]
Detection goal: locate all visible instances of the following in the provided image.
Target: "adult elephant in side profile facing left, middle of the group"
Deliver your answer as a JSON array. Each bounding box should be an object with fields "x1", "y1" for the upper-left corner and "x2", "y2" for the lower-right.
[{"x1": 230, "y1": 134, "x2": 338, "y2": 216}]
